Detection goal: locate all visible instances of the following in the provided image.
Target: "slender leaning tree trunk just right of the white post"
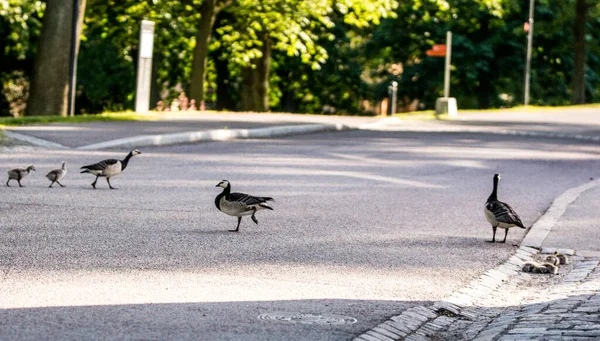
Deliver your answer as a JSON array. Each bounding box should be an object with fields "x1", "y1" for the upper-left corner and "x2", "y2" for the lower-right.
[{"x1": 189, "y1": 0, "x2": 218, "y2": 108}]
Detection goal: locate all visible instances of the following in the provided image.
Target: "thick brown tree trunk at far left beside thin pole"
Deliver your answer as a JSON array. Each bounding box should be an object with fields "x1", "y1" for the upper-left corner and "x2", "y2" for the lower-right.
[{"x1": 27, "y1": 0, "x2": 86, "y2": 116}]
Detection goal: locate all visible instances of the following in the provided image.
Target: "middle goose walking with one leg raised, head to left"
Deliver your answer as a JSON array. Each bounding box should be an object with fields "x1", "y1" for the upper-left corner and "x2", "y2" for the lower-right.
[{"x1": 215, "y1": 180, "x2": 273, "y2": 232}]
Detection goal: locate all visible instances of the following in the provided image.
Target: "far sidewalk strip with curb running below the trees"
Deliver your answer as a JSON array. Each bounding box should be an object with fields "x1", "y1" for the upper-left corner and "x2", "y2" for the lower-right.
[{"x1": 5, "y1": 108, "x2": 600, "y2": 149}]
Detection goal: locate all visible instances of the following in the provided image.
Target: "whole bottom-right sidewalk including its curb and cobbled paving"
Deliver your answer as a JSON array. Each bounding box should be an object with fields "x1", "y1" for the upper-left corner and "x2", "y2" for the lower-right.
[{"x1": 355, "y1": 180, "x2": 600, "y2": 341}]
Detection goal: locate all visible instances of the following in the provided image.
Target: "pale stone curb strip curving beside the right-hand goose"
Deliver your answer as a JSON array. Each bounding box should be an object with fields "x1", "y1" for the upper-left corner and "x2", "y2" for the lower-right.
[{"x1": 353, "y1": 179, "x2": 600, "y2": 341}]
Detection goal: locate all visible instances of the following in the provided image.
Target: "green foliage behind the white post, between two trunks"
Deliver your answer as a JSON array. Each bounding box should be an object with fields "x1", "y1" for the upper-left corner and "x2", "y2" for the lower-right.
[{"x1": 78, "y1": 0, "x2": 200, "y2": 112}]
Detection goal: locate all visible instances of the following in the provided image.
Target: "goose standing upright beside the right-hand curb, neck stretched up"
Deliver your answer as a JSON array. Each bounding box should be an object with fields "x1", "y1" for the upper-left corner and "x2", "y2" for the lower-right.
[{"x1": 484, "y1": 174, "x2": 526, "y2": 243}]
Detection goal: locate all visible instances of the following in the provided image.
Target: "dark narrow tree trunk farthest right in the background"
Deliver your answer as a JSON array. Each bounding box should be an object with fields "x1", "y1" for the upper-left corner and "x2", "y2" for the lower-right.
[{"x1": 571, "y1": 0, "x2": 589, "y2": 104}]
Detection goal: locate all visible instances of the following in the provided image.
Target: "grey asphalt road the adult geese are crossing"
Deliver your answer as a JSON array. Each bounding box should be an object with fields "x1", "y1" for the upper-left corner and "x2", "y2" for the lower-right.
[{"x1": 0, "y1": 131, "x2": 600, "y2": 340}]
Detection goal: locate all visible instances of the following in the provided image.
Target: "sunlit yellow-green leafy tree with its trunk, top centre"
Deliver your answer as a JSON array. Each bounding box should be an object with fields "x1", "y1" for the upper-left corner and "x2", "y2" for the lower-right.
[{"x1": 217, "y1": 0, "x2": 396, "y2": 111}]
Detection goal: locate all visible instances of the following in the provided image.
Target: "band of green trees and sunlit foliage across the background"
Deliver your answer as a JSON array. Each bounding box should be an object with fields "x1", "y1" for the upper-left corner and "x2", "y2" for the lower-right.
[{"x1": 0, "y1": 0, "x2": 600, "y2": 115}]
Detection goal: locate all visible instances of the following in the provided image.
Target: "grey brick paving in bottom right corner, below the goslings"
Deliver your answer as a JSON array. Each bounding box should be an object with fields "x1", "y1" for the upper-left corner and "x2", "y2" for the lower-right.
[{"x1": 395, "y1": 254, "x2": 600, "y2": 341}]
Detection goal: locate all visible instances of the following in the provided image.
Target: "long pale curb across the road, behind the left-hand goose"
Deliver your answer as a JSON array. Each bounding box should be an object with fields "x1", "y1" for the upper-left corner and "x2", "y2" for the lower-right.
[{"x1": 77, "y1": 124, "x2": 351, "y2": 150}]
